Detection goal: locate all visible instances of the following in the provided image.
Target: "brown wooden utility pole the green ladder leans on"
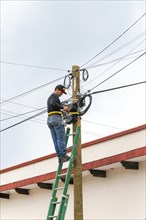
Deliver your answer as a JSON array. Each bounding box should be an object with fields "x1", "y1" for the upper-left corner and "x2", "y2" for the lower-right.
[{"x1": 72, "y1": 66, "x2": 83, "y2": 220}]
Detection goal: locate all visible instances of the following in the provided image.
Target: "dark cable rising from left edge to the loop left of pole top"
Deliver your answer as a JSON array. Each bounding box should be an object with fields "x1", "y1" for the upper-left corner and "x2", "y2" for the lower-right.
[{"x1": 0, "y1": 76, "x2": 68, "y2": 104}]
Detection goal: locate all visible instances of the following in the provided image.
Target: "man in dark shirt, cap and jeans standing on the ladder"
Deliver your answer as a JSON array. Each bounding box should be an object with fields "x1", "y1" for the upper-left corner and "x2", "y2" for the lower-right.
[{"x1": 47, "y1": 85, "x2": 70, "y2": 163}]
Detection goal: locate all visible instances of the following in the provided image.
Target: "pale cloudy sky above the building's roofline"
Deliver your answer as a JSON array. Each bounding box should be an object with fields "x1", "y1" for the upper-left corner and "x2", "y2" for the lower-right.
[{"x1": 0, "y1": 0, "x2": 146, "y2": 169}]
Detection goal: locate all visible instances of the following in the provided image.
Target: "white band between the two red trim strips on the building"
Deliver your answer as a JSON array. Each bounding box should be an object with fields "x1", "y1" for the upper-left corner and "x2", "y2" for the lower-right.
[{"x1": 0, "y1": 129, "x2": 146, "y2": 185}]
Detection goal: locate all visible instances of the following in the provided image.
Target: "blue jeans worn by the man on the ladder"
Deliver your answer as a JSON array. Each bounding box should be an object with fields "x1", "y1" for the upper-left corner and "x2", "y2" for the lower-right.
[{"x1": 47, "y1": 115, "x2": 67, "y2": 159}]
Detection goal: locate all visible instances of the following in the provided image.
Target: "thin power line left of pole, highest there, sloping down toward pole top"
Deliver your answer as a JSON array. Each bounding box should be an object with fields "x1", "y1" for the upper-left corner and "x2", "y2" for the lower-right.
[{"x1": 0, "y1": 60, "x2": 69, "y2": 72}]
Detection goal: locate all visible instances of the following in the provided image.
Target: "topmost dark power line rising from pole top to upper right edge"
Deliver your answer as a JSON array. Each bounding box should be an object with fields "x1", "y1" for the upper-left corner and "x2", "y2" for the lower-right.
[{"x1": 80, "y1": 13, "x2": 146, "y2": 67}]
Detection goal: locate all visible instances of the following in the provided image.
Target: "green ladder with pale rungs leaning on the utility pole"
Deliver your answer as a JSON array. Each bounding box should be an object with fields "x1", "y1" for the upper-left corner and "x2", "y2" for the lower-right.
[{"x1": 46, "y1": 126, "x2": 80, "y2": 220}]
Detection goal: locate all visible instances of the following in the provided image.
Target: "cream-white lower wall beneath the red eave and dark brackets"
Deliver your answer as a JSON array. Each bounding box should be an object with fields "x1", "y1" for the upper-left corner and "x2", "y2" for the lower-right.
[{"x1": 0, "y1": 162, "x2": 146, "y2": 220}]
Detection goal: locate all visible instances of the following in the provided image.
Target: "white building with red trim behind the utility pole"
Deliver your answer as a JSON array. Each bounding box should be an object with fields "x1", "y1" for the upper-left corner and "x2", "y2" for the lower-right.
[{"x1": 0, "y1": 125, "x2": 146, "y2": 220}]
